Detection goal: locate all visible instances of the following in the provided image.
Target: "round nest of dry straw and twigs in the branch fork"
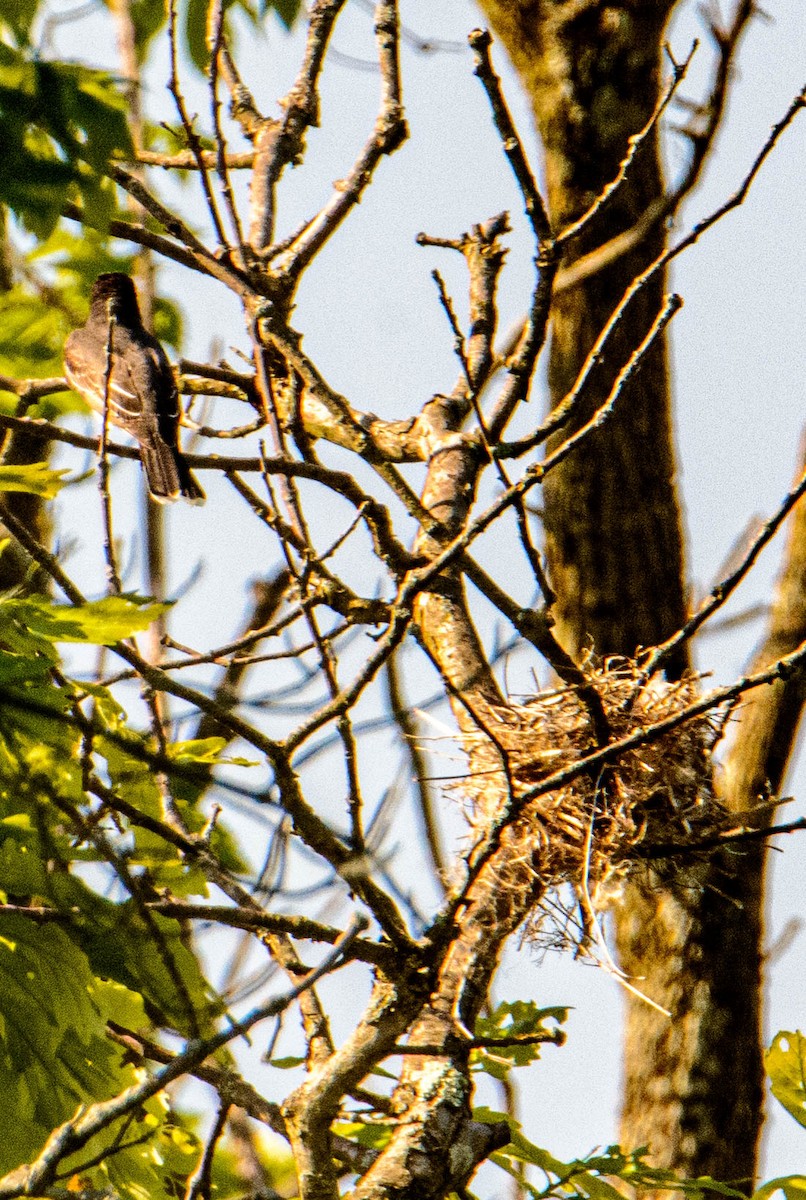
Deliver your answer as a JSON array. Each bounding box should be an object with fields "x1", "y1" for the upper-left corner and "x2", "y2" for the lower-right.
[{"x1": 450, "y1": 659, "x2": 728, "y2": 942}]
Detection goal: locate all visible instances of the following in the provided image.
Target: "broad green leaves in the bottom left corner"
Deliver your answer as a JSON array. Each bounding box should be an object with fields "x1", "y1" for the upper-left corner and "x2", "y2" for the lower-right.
[{"x1": 0, "y1": 912, "x2": 198, "y2": 1185}]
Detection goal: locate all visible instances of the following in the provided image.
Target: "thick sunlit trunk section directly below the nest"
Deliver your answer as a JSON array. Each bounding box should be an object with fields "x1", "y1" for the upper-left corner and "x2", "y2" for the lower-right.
[{"x1": 618, "y1": 848, "x2": 763, "y2": 1187}]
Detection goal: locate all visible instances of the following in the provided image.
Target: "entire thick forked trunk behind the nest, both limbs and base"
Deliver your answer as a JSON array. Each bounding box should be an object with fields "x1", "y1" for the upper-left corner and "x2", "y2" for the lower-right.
[{"x1": 481, "y1": 0, "x2": 806, "y2": 1183}]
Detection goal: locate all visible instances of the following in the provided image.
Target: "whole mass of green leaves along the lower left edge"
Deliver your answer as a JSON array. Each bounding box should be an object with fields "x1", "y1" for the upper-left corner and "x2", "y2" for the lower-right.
[{"x1": 0, "y1": 585, "x2": 245, "y2": 1200}]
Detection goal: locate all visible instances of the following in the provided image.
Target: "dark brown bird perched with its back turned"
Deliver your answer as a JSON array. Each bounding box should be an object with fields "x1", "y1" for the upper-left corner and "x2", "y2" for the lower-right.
[{"x1": 64, "y1": 271, "x2": 205, "y2": 504}]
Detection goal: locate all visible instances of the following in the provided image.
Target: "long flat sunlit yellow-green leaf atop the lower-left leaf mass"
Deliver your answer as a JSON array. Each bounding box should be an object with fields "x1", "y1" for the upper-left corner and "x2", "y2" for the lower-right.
[{"x1": 0, "y1": 595, "x2": 170, "y2": 648}]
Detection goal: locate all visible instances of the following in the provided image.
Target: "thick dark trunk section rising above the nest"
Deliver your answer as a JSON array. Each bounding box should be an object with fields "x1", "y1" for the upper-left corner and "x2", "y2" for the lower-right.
[{"x1": 482, "y1": 0, "x2": 685, "y2": 672}]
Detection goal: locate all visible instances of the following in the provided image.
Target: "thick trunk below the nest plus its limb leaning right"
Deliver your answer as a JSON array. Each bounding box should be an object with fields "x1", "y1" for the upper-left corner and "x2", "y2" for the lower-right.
[{"x1": 619, "y1": 458, "x2": 806, "y2": 1186}]
